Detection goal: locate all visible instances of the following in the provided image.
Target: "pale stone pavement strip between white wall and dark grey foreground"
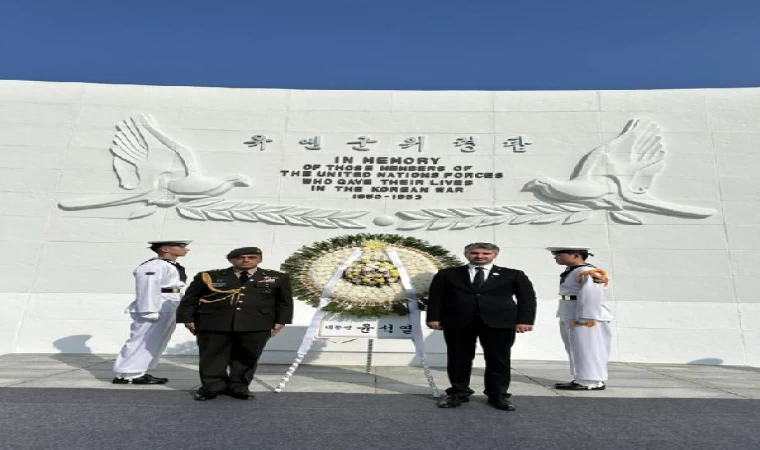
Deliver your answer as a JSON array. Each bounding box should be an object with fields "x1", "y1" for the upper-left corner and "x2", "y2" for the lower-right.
[{"x1": 0, "y1": 354, "x2": 760, "y2": 401}]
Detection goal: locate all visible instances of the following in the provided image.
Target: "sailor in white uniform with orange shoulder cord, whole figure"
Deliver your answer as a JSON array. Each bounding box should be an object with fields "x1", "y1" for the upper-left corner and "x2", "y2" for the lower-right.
[{"x1": 547, "y1": 247, "x2": 612, "y2": 391}]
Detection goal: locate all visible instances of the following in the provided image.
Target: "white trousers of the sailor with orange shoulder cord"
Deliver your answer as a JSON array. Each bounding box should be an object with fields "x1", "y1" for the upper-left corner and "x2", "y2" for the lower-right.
[{"x1": 559, "y1": 319, "x2": 612, "y2": 385}]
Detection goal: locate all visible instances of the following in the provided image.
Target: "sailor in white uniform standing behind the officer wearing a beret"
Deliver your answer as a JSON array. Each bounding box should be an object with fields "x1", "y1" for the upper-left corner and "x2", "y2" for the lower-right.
[{"x1": 113, "y1": 240, "x2": 192, "y2": 384}]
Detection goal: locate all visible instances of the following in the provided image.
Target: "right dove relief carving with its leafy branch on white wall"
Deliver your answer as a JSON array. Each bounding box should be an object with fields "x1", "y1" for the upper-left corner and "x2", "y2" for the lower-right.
[{"x1": 397, "y1": 119, "x2": 717, "y2": 230}]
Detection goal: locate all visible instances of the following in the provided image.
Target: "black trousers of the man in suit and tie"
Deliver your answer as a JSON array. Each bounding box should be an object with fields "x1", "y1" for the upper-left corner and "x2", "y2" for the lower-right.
[{"x1": 443, "y1": 317, "x2": 515, "y2": 397}]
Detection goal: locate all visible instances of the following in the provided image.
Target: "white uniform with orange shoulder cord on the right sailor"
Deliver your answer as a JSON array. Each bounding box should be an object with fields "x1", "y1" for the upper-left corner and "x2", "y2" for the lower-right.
[{"x1": 557, "y1": 265, "x2": 612, "y2": 386}]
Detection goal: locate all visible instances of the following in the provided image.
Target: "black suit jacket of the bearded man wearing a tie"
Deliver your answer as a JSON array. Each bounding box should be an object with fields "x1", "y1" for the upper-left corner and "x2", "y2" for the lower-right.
[{"x1": 427, "y1": 265, "x2": 536, "y2": 329}]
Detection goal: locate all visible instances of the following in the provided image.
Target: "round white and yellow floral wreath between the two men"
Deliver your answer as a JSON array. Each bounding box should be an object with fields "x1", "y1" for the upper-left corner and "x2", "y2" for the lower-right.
[{"x1": 280, "y1": 234, "x2": 461, "y2": 317}]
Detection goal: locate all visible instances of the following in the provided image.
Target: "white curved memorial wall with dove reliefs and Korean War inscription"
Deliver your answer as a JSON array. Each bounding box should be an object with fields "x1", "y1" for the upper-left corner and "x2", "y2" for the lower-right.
[{"x1": 0, "y1": 81, "x2": 760, "y2": 366}]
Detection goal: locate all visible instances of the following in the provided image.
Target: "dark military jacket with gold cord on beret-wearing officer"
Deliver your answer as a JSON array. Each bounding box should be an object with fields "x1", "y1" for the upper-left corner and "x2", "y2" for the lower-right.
[{"x1": 177, "y1": 267, "x2": 293, "y2": 331}]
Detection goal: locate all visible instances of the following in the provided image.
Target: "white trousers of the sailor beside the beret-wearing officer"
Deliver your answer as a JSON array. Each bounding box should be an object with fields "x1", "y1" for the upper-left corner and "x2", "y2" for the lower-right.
[{"x1": 113, "y1": 312, "x2": 177, "y2": 376}]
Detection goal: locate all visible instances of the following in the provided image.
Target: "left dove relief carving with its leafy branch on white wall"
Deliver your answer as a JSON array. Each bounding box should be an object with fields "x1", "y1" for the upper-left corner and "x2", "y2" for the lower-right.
[{"x1": 58, "y1": 114, "x2": 368, "y2": 228}]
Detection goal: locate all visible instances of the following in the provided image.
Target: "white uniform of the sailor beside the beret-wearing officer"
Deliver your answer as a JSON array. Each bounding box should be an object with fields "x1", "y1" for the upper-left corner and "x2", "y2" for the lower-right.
[{"x1": 113, "y1": 258, "x2": 185, "y2": 378}]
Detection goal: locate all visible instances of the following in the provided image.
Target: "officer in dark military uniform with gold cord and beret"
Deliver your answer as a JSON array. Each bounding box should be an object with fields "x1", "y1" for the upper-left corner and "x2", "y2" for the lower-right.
[{"x1": 177, "y1": 247, "x2": 293, "y2": 401}]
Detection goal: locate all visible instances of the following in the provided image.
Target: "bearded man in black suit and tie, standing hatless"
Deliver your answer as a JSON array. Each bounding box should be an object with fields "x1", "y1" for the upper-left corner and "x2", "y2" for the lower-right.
[{"x1": 427, "y1": 242, "x2": 536, "y2": 411}]
